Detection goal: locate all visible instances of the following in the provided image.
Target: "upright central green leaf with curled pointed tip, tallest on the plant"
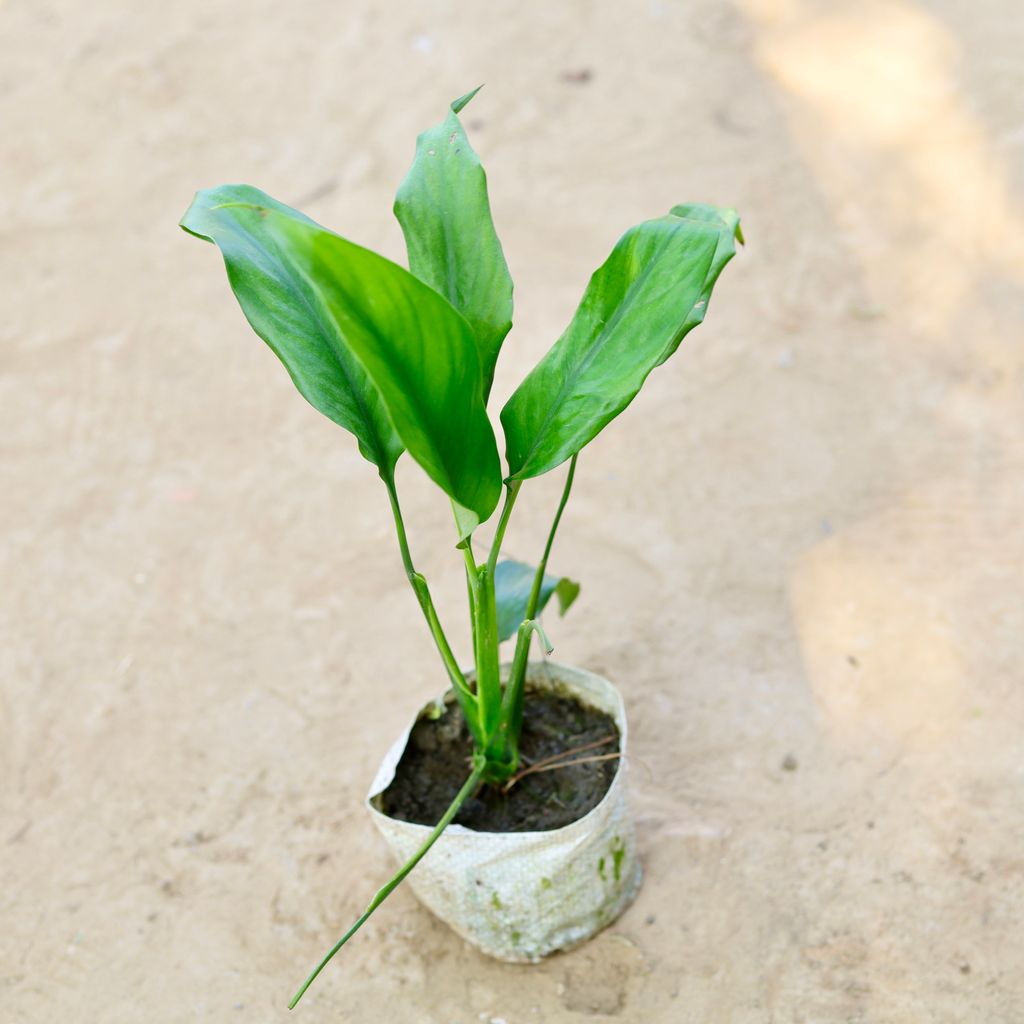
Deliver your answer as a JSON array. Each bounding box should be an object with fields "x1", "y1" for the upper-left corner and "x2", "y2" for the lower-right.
[{"x1": 394, "y1": 89, "x2": 512, "y2": 401}]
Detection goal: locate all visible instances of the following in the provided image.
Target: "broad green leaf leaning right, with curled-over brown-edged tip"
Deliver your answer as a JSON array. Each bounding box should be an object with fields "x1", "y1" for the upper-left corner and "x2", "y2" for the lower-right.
[{"x1": 502, "y1": 214, "x2": 731, "y2": 479}]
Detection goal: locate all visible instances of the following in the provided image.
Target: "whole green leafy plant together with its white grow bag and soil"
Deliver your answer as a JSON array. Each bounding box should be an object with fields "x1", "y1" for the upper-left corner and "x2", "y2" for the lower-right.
[{"x1": 181, "y1": 81, "x2": 742, "y2": 1007}]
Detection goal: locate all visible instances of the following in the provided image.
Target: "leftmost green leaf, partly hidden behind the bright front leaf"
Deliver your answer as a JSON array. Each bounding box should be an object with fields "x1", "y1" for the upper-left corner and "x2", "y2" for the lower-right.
[{"x1": 181, "y1": 185, "x2": 403, "y2": 476}]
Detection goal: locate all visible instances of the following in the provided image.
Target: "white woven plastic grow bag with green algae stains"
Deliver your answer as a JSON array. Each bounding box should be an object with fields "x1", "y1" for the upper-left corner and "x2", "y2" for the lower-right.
[{"x1": 367, "y1": 662, "x2": 641, "y2": 963}]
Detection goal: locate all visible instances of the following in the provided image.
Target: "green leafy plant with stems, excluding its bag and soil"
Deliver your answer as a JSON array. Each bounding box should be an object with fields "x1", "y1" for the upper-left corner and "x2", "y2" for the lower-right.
[{"x1": 181, "y1": 90, "x2": 742, "y2": 1007}]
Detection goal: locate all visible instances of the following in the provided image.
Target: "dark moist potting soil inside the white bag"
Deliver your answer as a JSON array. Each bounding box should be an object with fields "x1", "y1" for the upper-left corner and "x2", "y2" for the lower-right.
[{"x1": 380, "y1": 685, "x2": 618, "y2": 831}]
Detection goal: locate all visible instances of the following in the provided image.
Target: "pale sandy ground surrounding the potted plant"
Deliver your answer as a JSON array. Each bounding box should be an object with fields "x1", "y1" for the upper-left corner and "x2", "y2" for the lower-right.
[{"x1": 0, "y1": 0, "x2": 1024, "y2": 1024}]
